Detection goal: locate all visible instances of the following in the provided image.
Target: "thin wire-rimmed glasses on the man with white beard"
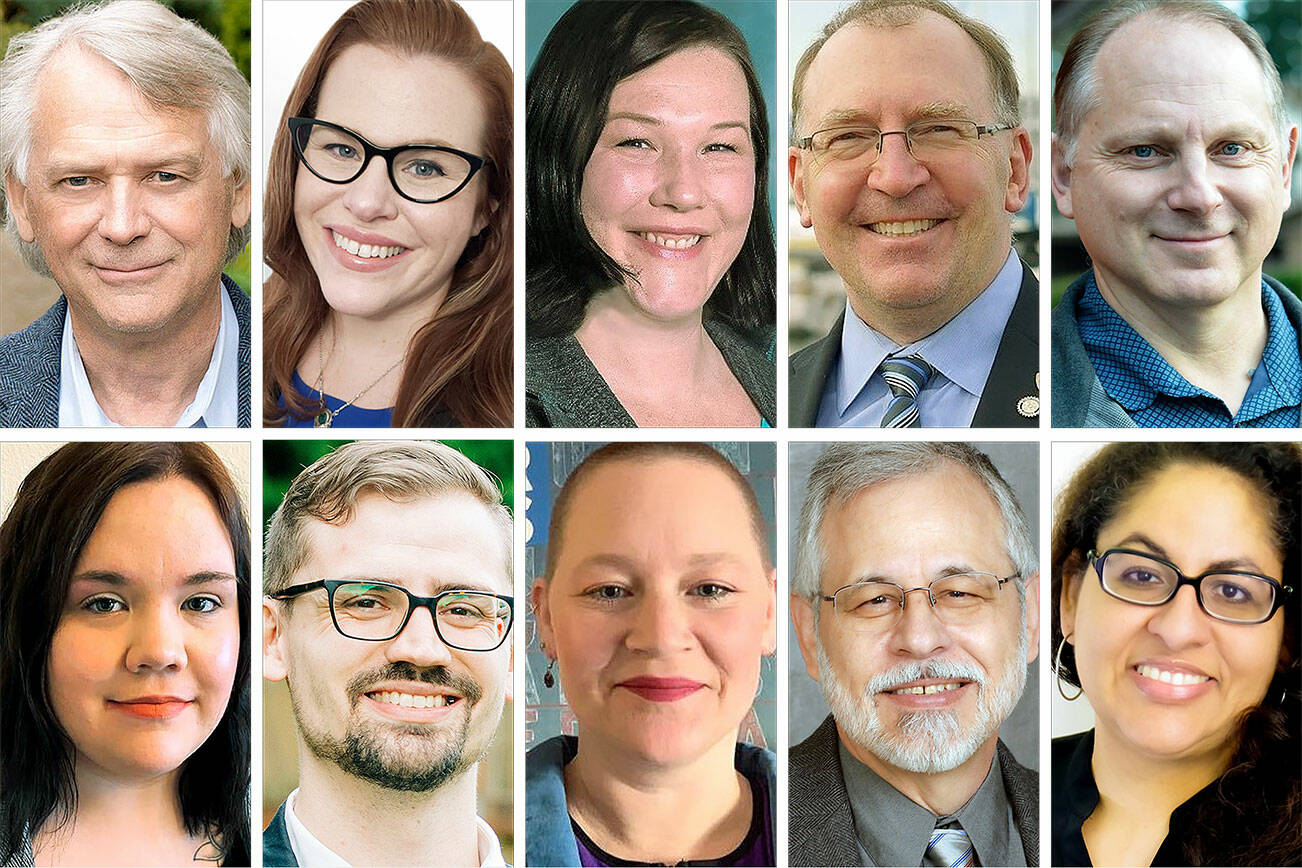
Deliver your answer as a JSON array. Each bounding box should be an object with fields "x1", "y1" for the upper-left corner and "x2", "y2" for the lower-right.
[{"x1": 819, "y1": 571, "x2": 1018, "y2": 630}]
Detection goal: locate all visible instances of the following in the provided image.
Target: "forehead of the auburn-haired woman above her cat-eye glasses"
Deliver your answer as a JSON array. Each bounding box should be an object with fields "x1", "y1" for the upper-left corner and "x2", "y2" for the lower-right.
[{"x1": 315, "y1": 44, "x2": 487, "y2": 152}]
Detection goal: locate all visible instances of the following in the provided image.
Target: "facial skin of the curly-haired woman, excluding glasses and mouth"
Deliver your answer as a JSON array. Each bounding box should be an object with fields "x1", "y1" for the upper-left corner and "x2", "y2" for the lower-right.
[{"x1": 1060, "y1": 465, "x2": 1284, "y2": 765}]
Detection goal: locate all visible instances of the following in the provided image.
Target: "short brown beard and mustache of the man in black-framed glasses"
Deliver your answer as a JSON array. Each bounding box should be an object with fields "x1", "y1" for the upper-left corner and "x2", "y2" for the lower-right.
[{"x1": 289, "y1": 662, "x2": 487, "y2": 793}]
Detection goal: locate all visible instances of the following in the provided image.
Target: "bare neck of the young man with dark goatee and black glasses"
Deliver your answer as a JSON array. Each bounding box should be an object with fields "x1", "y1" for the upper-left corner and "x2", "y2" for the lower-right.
[{"x1": 294, "y1": 742, "x2": 479, "y2": 865}]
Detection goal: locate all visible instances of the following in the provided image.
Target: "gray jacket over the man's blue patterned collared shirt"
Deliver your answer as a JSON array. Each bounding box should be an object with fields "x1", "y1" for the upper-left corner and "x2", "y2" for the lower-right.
[{"x1": 1049, "y1": 272, "x2": 1302, "y2": 428}]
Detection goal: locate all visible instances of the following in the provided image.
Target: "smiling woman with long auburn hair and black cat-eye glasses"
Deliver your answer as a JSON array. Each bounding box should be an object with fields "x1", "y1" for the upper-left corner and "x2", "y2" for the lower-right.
[{"x1": 263, "y1": 0, "x2": 512, "y2": 427}]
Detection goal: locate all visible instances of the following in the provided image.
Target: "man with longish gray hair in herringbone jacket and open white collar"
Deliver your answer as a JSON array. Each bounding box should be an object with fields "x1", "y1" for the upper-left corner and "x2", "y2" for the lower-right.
[{"x1": 0, "y1": 0, "x2": 250, "y2": 427}]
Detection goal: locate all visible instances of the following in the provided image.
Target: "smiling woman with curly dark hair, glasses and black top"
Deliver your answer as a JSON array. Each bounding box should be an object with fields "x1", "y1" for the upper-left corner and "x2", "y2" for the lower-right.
[{"x1": 1052, "y1": 442, "x2": 1302, "y2": 865}]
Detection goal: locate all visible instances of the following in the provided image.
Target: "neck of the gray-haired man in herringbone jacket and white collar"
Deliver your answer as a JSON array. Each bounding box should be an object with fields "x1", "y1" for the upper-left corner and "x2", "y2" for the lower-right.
[{"x1": 68, "y1": 289, "x2": 225, "y2": 427}]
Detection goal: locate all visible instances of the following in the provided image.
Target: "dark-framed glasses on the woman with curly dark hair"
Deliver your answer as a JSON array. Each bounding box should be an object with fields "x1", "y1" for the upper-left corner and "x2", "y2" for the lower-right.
[{"x1": 1086, "y1": 549, "x2": 1293, "y2": 623}]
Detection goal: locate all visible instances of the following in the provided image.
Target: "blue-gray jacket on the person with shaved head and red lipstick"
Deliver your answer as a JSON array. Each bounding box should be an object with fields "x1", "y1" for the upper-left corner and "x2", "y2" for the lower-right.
[{"x1": 525, "y1": 735, "x2": 777, "y2": 868}]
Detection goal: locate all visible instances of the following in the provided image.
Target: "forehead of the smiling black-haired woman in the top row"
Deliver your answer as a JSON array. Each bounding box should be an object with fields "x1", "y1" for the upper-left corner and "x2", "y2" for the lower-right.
[{"x1": 609, "y1": 46, "x2": 750, "y2": 122}]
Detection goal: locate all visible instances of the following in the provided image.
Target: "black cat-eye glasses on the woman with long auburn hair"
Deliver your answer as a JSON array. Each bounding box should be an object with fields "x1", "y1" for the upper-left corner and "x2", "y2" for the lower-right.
[{"x1": 288, "y1": 117, "x2": 488, "y2": 204}]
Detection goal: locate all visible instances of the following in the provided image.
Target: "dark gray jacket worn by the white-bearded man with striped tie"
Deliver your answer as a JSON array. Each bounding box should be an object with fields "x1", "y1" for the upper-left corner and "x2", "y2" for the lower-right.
[{"x1": 788, "y1": 714, "x2": 1040, "y2": 865}]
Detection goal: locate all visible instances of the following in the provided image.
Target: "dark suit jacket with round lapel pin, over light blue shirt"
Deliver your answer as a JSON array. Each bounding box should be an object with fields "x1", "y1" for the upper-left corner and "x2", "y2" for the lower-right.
[{"x1": 788, "y1": 262, "x2": 1040, "y2": 428}]
